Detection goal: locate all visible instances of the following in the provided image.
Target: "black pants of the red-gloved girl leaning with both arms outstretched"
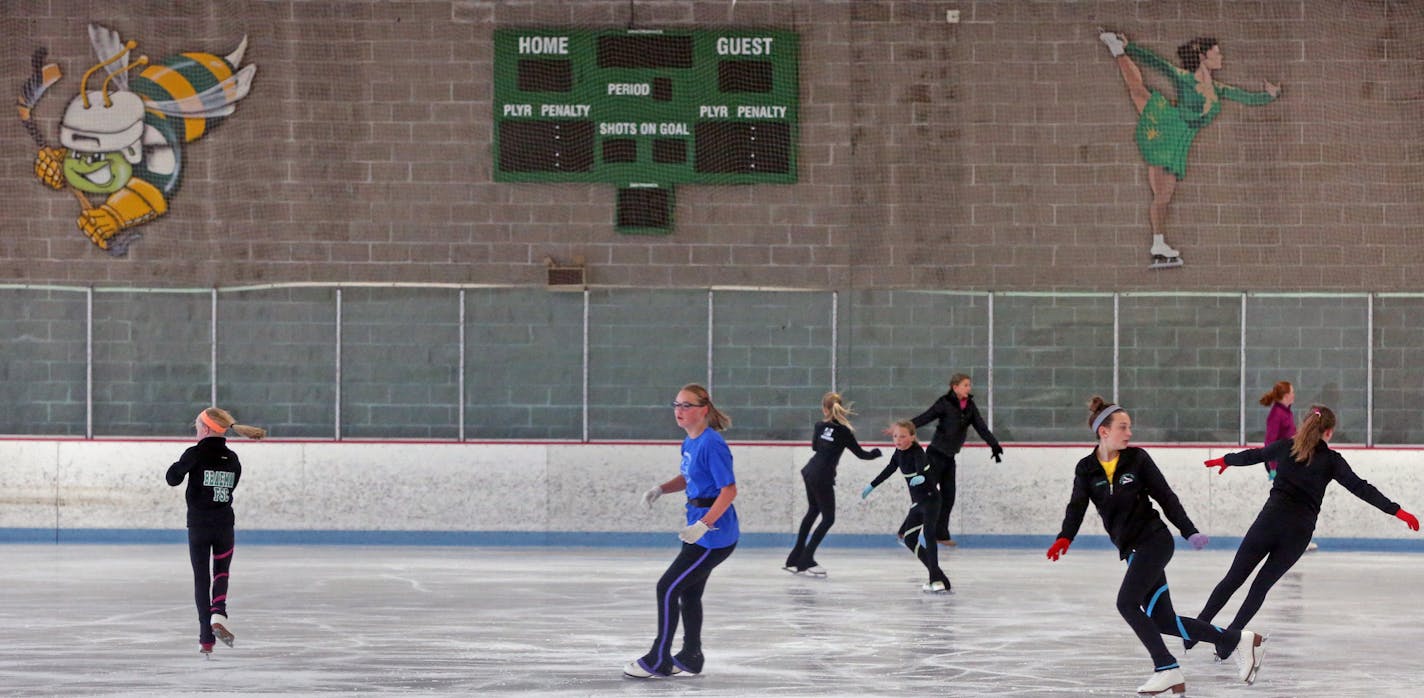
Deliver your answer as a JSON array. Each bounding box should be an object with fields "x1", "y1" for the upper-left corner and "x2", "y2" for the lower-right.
[{"x1": 1198, "y1": 511, "x2": 1316, "y2": 630}]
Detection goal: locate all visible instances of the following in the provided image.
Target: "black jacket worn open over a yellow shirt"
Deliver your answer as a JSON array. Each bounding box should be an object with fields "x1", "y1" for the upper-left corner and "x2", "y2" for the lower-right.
[{"x1": 1058, "y1": 446, "x2": 1198, "y2": 560}]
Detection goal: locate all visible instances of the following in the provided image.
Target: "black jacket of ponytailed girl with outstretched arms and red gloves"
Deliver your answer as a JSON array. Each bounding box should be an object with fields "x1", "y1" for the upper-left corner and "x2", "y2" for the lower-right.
[{"x1": 1225, "y1": 439, "x2": 1400, "y2": 526}]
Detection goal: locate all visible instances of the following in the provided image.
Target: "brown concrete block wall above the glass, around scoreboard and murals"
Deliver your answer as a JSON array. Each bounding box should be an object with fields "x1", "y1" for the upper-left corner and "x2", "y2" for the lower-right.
[{"x1": 0, "y1": 0, "x2": 1424, "y2": 291}]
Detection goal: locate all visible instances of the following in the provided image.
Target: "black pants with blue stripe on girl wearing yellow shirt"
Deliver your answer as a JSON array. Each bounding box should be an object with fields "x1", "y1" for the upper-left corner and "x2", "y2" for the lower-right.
[{"x1": 1118, "y1": 528, "x2": 1242, "y2": 671}]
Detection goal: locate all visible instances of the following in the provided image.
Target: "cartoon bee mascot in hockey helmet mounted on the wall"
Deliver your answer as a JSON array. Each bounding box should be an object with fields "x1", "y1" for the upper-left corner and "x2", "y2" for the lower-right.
[{"x1": 20, "y1": 24, "x2": 256, "y2": 256}]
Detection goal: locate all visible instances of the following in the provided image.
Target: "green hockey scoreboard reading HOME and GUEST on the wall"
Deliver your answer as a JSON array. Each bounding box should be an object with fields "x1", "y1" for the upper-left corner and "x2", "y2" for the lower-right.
[{"x1": 494, "y1": 28, "x2": 799, "y2": 234}]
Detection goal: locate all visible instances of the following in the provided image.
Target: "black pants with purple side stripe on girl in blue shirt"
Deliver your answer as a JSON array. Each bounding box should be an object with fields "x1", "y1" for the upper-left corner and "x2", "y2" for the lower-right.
[{"x1": 638, "y1": 543, "x2": 736, "y2": 675}]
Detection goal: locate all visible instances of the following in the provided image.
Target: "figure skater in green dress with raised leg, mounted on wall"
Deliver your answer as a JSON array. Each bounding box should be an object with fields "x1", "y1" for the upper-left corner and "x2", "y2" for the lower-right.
[{"x1": 1098, "y1": 31, "x2": 1280, "y2": 269}]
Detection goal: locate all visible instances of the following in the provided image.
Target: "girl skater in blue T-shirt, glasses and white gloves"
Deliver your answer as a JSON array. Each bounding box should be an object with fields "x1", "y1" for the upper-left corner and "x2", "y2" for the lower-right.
[{"x1": 624, "y1": 383, "x2": 740, "y2": 678}]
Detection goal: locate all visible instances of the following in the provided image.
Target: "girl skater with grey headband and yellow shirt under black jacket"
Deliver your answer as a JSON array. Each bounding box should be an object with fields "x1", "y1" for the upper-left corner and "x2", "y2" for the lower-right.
[{"x1": 1048, "y1": 395, "x2": 1263, "y2": 695}]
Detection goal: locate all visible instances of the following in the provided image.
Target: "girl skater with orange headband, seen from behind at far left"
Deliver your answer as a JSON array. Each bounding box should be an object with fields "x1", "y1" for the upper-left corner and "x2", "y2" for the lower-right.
[{"x1": 168, "y1": 407, "x2": 266, "y2": 654}]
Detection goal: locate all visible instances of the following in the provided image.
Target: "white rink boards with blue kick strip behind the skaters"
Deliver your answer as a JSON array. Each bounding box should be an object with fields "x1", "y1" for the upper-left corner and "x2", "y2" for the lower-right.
[{"x1": 0, "y1": 439, "x2": 1424, "y2": 551}]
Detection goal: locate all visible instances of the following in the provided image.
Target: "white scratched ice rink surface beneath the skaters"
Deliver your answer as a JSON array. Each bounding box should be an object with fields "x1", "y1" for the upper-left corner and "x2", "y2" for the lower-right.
[{"x1": 0, "y1": 541, "x2": 1424, "y2": 698}]
